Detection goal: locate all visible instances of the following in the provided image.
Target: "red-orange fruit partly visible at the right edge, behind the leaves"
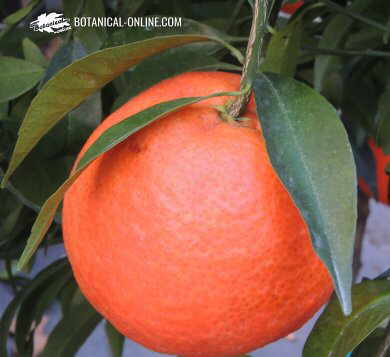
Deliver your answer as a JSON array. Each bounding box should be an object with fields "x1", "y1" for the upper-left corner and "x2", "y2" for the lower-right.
[{"x1": 359, "y1": 138, "x2": 390, "y2": 204}]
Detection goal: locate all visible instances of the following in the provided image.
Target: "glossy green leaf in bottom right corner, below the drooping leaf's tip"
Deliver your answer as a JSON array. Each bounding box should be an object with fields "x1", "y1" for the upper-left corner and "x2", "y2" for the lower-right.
[{"x1": 303, "y1": 280, "x2": 390, "y2": 357}]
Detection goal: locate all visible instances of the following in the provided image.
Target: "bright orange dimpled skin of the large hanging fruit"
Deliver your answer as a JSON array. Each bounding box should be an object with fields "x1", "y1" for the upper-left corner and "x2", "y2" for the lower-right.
[{"x1": 63, "y1": 72, "x2": 332, "y2": 357}]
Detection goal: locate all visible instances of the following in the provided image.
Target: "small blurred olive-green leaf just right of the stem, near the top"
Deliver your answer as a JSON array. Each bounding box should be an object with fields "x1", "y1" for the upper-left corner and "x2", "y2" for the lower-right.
[{"x1": 261, "y1": 20, "x2": 303, "y2": 77}]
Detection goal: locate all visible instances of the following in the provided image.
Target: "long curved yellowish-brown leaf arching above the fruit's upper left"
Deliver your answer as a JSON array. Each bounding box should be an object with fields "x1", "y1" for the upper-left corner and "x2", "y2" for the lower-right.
[{"x1": 1, "y1": 35, "x2": 213, "y2": 187}]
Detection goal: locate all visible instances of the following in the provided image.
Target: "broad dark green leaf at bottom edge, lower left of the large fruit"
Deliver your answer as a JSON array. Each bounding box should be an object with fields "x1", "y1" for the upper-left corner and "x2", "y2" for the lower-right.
[{"x1": 40, "y1": 300, "x2": 102, "y2": 357}]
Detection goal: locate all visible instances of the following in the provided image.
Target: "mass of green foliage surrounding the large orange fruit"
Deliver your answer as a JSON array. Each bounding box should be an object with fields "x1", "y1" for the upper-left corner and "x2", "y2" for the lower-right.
[{"x1": 0, "y1": 0, "x2": 390, "y2": 357}]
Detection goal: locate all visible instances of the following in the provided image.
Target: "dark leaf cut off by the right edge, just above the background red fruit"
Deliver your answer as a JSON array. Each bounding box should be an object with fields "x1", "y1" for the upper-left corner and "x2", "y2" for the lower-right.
[{"x1": 375, "y1": 80, "x2": 390, "y2": 155}]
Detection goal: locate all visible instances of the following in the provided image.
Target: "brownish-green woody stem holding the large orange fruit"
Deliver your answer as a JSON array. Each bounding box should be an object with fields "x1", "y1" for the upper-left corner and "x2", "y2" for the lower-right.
[{"x1": 228, "y1": 0, "x2": 274, "y2": 118}]
